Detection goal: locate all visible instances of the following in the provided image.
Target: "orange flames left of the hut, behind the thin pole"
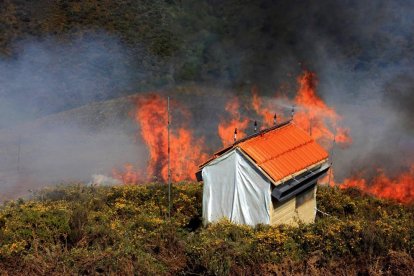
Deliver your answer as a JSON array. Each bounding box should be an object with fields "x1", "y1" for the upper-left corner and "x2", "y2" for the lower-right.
[{"x1": 114, "y1": 94, "x2": 207, "y2": 184}]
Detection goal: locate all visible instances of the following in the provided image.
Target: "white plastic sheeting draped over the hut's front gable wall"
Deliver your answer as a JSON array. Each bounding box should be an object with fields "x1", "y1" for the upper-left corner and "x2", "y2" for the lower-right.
[{"x1": 202, "y1": 149, "x2": 272, "y2": 225}]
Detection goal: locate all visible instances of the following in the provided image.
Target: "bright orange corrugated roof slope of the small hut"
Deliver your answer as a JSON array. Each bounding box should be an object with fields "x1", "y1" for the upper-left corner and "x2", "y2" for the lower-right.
[{"x1": 235, "y1": 123, "x2": 328, "y2": 181}]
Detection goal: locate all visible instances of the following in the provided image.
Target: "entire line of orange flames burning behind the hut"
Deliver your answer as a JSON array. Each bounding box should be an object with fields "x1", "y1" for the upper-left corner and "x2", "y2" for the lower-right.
[{"x1": 113, "y1": 71, "x2": 414, "y2": 203}]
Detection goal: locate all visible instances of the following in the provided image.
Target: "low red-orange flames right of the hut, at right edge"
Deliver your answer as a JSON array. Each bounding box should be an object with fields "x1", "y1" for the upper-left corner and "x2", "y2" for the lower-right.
[{"x1": 340, "y1": 164, "x2": 414, "y2": 203}]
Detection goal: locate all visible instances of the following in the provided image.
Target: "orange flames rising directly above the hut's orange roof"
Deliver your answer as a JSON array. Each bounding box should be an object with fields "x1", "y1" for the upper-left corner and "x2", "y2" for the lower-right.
[{"x1": 218, "y1": 71, "x2": 352, "y2": 149}]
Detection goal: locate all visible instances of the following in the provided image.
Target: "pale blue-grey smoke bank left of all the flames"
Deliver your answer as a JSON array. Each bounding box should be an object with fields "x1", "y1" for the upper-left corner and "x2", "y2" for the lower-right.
[{"x1": 0, "y1": 34, "x2": 146, "y2": 199}]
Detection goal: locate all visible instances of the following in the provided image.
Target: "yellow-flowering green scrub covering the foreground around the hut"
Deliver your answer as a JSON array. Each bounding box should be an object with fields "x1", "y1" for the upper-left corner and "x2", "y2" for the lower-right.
[{"x1": 0, "y1": 183, "x2": 414, "y2": 275}]
